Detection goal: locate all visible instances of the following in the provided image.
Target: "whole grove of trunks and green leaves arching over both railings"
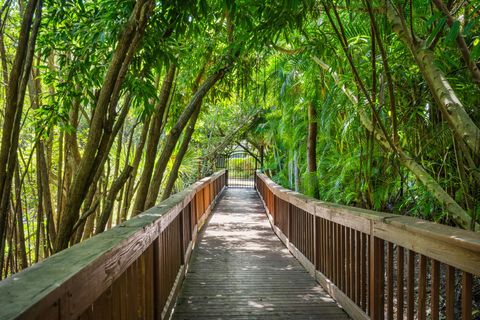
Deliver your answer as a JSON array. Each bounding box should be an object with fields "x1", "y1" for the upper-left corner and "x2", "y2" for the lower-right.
[{"x1": 0, "y1": 0, "x2": 480, "y2": 278}]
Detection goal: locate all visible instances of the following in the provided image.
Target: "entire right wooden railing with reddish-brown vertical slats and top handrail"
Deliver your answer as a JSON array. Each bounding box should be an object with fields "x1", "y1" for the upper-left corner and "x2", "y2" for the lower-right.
[{"x1": 255, "y1": 172, "x2": 480, "y2": 320}]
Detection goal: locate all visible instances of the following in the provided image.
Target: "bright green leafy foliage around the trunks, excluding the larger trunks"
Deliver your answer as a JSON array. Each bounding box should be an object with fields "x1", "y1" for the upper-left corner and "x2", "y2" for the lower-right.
[{"x1": 0, "y1": 0, "x2": 480, "y2": 278}]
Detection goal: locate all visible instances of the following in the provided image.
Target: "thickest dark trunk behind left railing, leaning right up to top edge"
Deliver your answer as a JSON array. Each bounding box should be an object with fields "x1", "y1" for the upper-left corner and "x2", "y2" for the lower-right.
[{"x1": 55, "y1": 0, "x2": 154, "y2": 252}]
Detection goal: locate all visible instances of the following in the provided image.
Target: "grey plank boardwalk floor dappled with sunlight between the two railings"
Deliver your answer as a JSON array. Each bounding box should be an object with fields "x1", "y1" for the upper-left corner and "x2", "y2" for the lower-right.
[{"x1": 173, "y1": 189, "x2": 348, "y2": 319}]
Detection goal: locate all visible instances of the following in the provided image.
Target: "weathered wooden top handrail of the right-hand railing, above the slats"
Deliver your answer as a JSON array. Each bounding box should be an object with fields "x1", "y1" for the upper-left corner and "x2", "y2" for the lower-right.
[{"x1": 257, "y1": 171, "x2": 480, "y2": 275}]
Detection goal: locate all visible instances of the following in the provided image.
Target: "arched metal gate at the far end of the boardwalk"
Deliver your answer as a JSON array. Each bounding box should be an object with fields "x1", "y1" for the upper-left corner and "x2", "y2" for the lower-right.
[{"x1": 226, "y1": 151, "x2": 258, "y2": 188}]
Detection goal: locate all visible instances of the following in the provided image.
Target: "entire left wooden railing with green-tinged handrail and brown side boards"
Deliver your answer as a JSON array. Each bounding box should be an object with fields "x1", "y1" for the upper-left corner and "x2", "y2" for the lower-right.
[{"x1": 0, "y1": 170, "x2": 226, "y2": 320}]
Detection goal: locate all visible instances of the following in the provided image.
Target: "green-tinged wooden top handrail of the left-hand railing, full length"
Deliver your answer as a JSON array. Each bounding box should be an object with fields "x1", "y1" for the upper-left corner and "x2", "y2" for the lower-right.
[{"x1": 0, "y1": 170, "x2": 225, "y2": 319}]
